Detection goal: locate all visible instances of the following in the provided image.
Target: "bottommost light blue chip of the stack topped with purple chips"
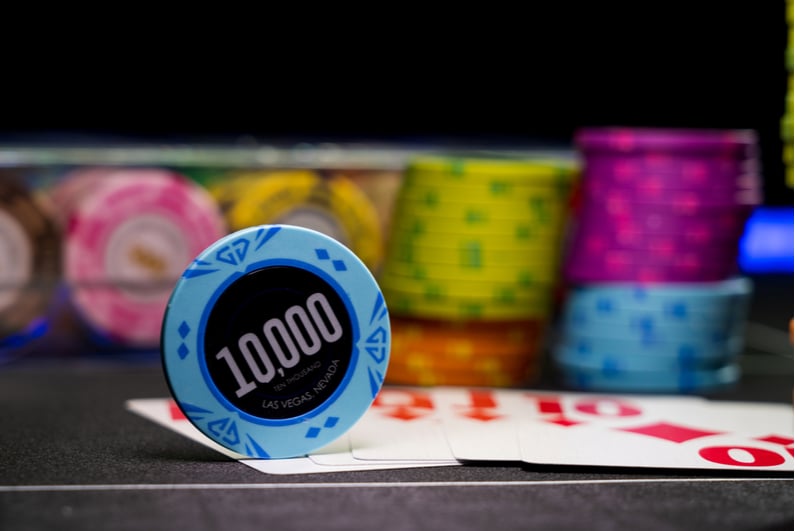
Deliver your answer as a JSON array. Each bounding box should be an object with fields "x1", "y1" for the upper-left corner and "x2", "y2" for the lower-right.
[{"x1": 561, "y1": 363, "x2": 741, "y2": 394}]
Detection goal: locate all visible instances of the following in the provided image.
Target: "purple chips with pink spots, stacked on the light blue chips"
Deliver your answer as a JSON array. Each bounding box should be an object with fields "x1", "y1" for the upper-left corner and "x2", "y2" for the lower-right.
[{"x1": 564, "y1": 128, "x2": 762, "y2": 283}]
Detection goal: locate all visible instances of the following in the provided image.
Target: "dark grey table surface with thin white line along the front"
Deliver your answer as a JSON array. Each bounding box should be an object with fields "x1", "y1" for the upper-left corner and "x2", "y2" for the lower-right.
[{"x1": 0, "y1": 276, "x2": 794, "y2": 531}]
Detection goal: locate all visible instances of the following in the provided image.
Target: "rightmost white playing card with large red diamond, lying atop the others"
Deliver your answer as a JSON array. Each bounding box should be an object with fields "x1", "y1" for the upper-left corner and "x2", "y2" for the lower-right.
[{"x1": 518, "y1": 394, "x2": 793, "y2": 471}]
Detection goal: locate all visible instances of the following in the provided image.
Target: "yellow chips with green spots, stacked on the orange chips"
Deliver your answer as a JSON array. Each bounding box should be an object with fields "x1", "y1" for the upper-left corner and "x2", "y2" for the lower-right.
[{"x1": 379, "y1": 153, "x2": 578, "y2": 321}]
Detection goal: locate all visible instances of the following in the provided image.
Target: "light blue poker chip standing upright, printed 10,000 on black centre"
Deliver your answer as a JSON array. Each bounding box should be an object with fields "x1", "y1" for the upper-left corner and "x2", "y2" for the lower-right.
[{"x1": 161, "y1": 225, "x2": 391, "y2": 459}]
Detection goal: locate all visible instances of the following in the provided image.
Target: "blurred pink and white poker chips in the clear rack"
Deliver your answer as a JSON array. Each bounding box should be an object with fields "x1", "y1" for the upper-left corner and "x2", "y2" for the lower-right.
[{"x1": 52, "y1": 168, "x2": 227, "y2": 349}]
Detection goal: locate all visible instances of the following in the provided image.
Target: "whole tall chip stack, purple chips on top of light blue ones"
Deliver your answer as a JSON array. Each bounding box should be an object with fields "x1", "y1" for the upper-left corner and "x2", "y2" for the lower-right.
[{"x1": 552, "y1": 128, "x2": 762, "y2": 393}]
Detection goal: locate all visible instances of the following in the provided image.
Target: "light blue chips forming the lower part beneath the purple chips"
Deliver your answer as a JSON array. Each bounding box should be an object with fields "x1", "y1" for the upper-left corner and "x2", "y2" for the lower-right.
[{"x1": 553, "y1": 278, "x2": 752, "y2": 393}]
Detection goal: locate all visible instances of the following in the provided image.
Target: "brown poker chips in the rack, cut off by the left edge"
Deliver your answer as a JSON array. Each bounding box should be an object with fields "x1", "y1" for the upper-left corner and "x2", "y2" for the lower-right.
[{"x1": 0, "y1": 177, "x2": 61, "y2": 360}]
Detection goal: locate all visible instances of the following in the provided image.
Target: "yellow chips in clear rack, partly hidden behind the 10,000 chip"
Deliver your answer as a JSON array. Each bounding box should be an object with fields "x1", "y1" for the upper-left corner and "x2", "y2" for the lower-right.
[{"x1": 208, "y1": 169, "x2": 384, "y2": 272}]
